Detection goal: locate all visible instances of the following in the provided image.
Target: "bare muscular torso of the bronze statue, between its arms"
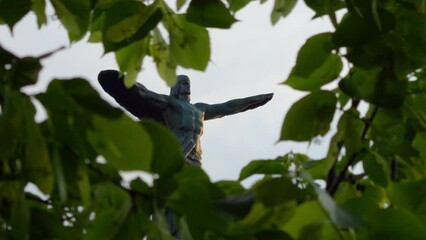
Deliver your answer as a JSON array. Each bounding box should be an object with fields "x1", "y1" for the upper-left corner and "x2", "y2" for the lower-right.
[{"x1": 164, "y1": 99, "x2": 204, "y2": 165}]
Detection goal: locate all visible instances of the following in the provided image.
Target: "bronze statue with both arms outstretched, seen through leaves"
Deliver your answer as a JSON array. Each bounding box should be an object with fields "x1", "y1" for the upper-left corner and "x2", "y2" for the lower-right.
[{"x1": 98, "y1": 70, "x2": 273, "y2": 166}]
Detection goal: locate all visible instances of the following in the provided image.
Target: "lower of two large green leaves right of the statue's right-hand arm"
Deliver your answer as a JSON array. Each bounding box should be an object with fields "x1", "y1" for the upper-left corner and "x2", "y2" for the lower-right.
[{"x1": 280, "y1": 91, "x2": 337, "y2": 141}]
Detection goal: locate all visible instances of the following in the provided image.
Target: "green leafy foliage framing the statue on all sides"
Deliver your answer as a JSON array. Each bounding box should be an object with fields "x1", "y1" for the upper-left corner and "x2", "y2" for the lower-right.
[{"x1": 0, "y1": 0, "x2": 426, "y2": 239}]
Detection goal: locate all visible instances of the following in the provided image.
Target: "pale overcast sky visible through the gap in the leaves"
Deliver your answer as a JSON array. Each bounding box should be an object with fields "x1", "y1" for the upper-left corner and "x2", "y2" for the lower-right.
[{"x1": 0, "y1": 0, "x2": 331, "y2": 186}]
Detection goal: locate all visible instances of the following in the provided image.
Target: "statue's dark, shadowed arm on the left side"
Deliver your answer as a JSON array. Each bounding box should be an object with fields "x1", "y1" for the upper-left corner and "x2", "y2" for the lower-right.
[{"x1": 98, "y1": 70, "x2": 165, "y2": 124}]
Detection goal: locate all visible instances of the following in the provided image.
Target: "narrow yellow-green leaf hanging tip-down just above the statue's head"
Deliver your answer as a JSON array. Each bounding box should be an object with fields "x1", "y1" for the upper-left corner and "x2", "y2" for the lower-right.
[{"x1": 149, "y1": 28, "x2": 176, "y2": 86}]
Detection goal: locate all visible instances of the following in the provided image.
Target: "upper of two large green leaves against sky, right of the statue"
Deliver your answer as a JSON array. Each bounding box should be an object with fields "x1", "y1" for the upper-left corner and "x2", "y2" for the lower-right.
[{"x1": 284, "y1": 33, "x2": 343, "y2": 91}]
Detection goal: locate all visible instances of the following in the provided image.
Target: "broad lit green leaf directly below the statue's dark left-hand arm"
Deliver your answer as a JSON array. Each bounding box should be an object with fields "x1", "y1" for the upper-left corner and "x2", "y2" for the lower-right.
[{"x1": 88, "y1": 116, "x2": 153, "y2": 172}]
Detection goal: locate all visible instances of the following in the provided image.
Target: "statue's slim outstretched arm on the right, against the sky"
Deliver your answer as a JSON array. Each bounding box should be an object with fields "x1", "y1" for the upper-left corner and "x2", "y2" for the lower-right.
[{"x1": 196, "y1": 93, "x2": 274, "y2": 120}]
